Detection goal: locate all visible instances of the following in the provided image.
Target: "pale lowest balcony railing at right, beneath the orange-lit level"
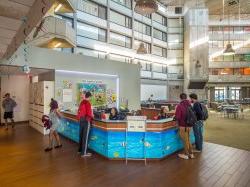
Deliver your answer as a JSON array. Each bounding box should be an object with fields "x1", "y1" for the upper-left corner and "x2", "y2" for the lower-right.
[{"x1": 209, "y1": 75, "x2": 250, "y2": 83}]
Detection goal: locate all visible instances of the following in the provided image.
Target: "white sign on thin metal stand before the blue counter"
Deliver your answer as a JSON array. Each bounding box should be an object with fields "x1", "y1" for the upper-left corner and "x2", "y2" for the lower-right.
[{"x1": 127, "y1": 116, "x2": 147, "y2": 132}]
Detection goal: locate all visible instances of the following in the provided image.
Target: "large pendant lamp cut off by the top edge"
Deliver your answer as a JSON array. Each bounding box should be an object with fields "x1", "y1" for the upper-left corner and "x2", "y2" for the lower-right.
[{"x1": 135, "y1": 0, "x2": 158, "y2": 15}]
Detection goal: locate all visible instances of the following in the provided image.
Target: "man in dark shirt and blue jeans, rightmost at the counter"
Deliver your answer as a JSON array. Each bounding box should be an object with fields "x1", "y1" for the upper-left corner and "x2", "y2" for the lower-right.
[{"x1": 189, "y1": 93, "x2": 203, "y2": 152}]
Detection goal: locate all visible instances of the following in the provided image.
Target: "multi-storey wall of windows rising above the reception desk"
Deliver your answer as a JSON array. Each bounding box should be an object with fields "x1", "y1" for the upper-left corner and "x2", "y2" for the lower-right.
[{"x1": 68, "y1": 0, "x2": 183, "y2": 79}]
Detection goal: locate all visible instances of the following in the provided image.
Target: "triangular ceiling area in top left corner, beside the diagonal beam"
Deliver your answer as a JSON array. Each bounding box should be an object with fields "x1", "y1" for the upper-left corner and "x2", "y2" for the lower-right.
[{"x1": 0, "y1": 0, "x2": 35, "y2": 59}]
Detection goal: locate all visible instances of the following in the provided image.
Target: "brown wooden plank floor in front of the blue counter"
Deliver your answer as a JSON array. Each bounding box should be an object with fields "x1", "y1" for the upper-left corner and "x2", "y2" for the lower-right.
[{"x1": 0, "y1": 125, "x2": 250, "y2": 187}]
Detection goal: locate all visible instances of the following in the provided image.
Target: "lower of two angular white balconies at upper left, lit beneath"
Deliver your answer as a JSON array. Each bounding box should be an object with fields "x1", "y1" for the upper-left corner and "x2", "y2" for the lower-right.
[{"x1": 31, "y1": 16, "x2": 76, "y2": 48}]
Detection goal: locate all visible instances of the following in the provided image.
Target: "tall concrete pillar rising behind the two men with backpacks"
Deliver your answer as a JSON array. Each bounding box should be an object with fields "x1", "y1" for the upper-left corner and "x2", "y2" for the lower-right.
[{"x1": 184, "y1": 8, "x2": 209, "y2": 93}]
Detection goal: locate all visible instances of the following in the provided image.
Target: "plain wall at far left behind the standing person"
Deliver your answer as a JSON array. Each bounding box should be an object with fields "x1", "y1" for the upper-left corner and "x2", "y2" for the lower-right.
[{"x1": 1, "y1": 75, "x2": 30, "y2": 122}]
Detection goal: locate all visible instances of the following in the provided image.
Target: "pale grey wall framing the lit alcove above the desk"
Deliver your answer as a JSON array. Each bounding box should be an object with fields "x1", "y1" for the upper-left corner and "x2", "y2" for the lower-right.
[{"x1": 2, "y1": 46, "x2": 140, "y2": 110}]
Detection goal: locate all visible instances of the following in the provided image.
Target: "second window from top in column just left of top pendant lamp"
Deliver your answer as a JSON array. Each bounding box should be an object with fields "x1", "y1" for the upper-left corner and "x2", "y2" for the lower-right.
[{"x1": 110, "y1": 10, "x2": 132, "y2": 29}]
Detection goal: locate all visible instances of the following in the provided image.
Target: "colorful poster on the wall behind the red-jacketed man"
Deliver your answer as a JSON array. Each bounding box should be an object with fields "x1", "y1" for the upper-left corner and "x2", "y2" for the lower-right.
[{"x1": 77, "y1": 83, "x2": 107, "y2": 107}]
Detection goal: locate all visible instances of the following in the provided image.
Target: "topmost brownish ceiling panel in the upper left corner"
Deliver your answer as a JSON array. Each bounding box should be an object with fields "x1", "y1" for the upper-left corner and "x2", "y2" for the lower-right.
[{"x1": 0, "y1": 0, "x2": 30, "y2": 20}]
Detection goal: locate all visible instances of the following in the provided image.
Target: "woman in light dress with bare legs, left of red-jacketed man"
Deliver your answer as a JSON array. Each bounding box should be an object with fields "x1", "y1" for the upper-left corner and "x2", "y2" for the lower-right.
[{"x1": 44, "y1": 98, "x2": 62, "y2": 152}]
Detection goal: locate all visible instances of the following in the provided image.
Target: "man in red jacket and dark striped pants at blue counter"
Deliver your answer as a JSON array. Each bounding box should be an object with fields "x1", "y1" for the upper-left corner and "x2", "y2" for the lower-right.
[{"x1": 77, "y1": 92, "x2": 94, "y2": 157}]
